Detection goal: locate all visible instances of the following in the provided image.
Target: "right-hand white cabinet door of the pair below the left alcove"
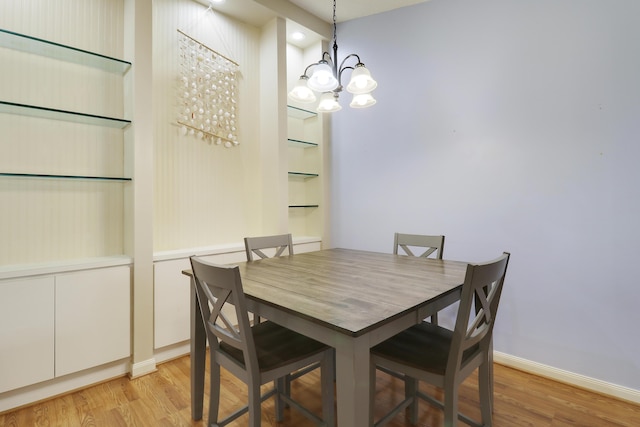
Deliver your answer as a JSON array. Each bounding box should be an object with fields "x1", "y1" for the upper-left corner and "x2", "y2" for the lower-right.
[{"x1": 55, "y1": 266, "x2": 131, "y2": 376}]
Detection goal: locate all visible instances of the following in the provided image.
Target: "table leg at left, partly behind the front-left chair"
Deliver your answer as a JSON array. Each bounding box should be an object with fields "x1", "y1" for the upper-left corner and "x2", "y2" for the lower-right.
[{"x1": 190, "y1": 278, "x2": 207, "y2": 420}]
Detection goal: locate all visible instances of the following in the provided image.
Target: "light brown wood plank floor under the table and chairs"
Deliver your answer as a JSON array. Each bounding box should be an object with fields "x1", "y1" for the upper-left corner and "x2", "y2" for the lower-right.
[{"x1": 0, "y1": 357, "x2": 640, "y2": 427}]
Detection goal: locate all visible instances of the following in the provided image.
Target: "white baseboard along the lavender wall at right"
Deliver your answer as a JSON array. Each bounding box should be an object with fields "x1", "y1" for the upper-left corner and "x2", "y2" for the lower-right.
[{"x1": 493, "y1": 351, "x2": 640, "y2": 404}]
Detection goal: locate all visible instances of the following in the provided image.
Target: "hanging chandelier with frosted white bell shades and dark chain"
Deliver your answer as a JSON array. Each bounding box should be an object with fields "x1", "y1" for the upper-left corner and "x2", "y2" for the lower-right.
[{"x1": 289, "y1": 0, "x2": 378, "y2": 113}]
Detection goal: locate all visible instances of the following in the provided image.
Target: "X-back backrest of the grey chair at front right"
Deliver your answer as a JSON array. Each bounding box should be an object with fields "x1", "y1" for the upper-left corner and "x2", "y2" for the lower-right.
[{"x1": 447, "y1": 252, "x2": 510, "y2": 371}]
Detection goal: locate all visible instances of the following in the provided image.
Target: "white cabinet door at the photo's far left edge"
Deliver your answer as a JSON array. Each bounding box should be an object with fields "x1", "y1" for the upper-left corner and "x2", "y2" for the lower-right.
[{"x1": 0, "y1": 277, "x2": 54, "y2": 393}]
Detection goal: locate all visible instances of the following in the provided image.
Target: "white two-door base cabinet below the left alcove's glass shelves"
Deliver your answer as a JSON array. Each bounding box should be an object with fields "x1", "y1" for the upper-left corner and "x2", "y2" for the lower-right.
[{"x1": 0, "y1": 266, "x2": 131, "y2": 393}]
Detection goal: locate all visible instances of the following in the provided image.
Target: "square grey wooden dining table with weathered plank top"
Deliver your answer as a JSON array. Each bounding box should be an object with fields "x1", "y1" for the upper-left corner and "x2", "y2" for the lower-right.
[{"x1": 183, "y1": 248, "x2": 467, "y2": 427}]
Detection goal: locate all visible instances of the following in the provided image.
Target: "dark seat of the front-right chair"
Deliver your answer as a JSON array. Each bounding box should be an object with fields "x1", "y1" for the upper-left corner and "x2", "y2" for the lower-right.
[{"x1": 371, "y1": 322, "x2": 479, "y2": 375}]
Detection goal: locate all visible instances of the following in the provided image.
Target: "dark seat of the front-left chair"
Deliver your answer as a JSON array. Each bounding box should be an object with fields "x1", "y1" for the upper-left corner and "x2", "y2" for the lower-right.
[{"x1": 220, "y1": 321, "x2": 328, "y2": 371}]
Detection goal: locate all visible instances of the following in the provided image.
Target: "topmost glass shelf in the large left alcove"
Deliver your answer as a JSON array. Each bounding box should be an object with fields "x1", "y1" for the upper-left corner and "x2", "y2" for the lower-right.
[{"x1": 0, "y1": 29, "x2": 131, "y2": 74}]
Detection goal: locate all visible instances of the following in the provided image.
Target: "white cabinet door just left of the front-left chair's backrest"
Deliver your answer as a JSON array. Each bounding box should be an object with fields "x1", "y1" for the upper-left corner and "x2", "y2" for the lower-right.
[{"x1": 153, "y1": 258, "x2": 191, "y2": 349}]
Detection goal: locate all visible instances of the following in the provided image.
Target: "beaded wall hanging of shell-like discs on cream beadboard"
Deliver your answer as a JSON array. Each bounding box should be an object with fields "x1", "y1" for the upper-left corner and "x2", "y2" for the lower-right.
[{"x1": 177, "y1": 30, "x2": 240, "y2": 148}]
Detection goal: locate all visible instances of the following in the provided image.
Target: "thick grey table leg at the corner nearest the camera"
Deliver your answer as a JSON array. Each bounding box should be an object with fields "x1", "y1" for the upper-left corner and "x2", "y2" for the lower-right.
[{"x1": 336, "y1": 336, "x2": 370, "y2": 427}]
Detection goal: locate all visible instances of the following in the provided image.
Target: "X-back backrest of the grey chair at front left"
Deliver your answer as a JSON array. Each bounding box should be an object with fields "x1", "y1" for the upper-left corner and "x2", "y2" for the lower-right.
[{"x1": 191, "y1": 256, "x2": 258, "y2": 372}]
